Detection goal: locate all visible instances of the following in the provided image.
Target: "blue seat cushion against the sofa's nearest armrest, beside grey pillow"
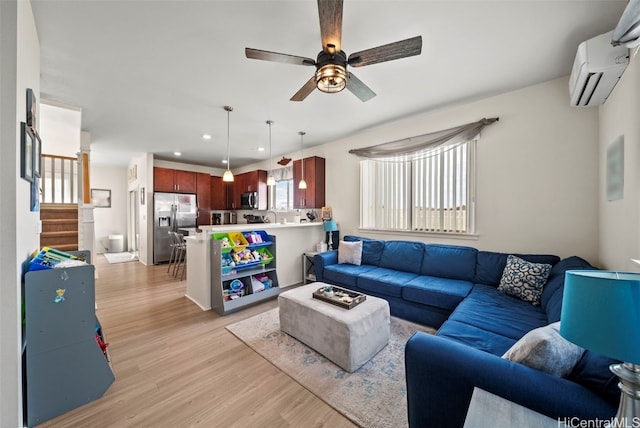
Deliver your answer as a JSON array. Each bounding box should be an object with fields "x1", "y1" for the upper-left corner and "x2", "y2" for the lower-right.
[{"x1": 436, "y1": 319, "x2": 516, "y2": 356}]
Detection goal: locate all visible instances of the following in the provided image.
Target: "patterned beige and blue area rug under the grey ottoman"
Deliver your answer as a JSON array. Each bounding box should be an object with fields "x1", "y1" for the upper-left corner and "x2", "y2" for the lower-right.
[{"x1": 227, "y1": 308, "x2": 434, "y2": 428}]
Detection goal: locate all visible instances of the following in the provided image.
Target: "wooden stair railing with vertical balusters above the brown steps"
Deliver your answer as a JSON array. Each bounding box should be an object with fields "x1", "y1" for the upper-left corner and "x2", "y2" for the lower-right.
[{"x1": 40, "y1": 154, "x2": 79, "y2": 204}]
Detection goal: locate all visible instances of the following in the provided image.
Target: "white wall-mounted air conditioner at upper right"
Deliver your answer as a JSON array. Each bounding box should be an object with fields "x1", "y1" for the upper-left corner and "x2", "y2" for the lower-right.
[{"x1": 569, "y1": 32, "x2": 629, "y2": 107}]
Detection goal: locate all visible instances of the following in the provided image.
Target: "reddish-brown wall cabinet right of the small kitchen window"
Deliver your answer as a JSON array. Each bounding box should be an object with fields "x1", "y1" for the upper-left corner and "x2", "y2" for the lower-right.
[{"x1": 293, "y1": 156, "x2": 325, "y2": 208}]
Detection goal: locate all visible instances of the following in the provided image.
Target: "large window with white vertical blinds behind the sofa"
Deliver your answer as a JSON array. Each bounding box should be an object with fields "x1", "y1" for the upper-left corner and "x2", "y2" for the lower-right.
[{"x1": 360, "y1": 140, "x2": 476, "y2": 234}]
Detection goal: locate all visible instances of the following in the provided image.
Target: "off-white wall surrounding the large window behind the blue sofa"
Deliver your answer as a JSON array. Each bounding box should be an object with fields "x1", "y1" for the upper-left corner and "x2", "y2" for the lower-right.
[{"x1": 272, "y1": 77, "x2": 600, "y2": 263}]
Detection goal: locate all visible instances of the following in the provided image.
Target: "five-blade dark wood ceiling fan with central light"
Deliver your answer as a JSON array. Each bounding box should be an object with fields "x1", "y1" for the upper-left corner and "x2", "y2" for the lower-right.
[{"x1": 244, "y1": 0, "x2": 422, "y2": 102}]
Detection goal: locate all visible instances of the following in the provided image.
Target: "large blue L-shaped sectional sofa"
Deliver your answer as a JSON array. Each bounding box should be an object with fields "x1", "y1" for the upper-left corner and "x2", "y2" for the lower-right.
[{"x1": 314, "y1": 236, "x2": 620, "y2": 427}]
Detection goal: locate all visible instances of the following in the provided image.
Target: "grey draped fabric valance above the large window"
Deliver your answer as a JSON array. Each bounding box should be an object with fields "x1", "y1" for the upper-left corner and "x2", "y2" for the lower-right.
[{"x1": 349, "y1": 117, "x2": 499, "y2": 161}]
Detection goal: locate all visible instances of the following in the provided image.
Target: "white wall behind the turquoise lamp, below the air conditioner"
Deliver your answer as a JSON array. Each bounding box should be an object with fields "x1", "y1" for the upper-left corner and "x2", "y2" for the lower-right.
[{"x1": 598, "y1": 48, "x2": 640, "y2": 271}]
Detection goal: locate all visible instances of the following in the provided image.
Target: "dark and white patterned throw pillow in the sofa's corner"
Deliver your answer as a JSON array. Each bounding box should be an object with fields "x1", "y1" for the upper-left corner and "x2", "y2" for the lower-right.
[{"x1": 498, "y1": 255, "x2": 551, "y2": 305}]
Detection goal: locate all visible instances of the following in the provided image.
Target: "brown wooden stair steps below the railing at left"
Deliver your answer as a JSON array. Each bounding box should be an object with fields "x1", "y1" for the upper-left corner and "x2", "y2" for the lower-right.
[{"x1": 40, "y1": 203, "x2": 78, "y2": 251}]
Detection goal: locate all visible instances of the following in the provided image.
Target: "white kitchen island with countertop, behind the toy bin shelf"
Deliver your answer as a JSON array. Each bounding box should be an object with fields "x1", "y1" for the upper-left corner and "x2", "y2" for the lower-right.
[{"x1": 185, "y1": 222, "x2": 325, "y2": 310}]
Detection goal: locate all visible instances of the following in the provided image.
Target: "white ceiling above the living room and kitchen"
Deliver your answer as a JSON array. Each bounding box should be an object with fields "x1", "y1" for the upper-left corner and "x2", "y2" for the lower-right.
[{"x1": 31, "y1": 0, "x2": 627, "y2": 168}]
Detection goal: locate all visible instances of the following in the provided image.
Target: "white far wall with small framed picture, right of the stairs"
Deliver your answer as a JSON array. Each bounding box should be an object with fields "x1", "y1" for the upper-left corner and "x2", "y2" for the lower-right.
[{"x1": 89, "y1": 165, "x2": 128, "y2": 253}]
